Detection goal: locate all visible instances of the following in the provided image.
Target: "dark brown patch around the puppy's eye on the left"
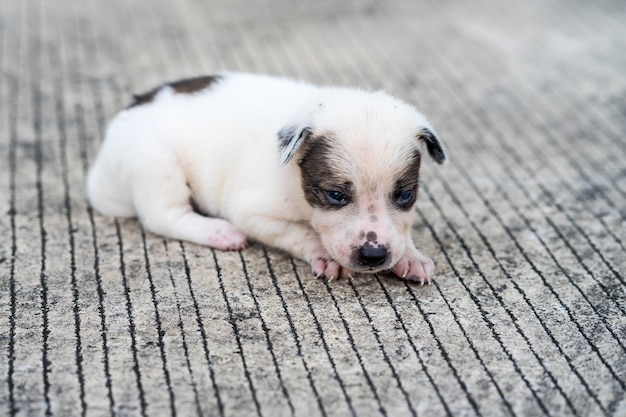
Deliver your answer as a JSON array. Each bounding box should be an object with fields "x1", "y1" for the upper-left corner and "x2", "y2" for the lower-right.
[{"x1": 299, "y1": 135, "x2": 354, "y2": 210}]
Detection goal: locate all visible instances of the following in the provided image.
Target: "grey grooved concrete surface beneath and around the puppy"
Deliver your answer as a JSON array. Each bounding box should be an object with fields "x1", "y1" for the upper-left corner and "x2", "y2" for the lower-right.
[{"x1": 0, "y1": 0, "x2": 626, "y2": 417}]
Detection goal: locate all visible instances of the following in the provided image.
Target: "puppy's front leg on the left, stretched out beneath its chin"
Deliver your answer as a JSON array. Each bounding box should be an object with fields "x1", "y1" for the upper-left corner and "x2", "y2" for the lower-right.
[{"x1": 241, "y1": 216, "x2": 352, "y2": 281}]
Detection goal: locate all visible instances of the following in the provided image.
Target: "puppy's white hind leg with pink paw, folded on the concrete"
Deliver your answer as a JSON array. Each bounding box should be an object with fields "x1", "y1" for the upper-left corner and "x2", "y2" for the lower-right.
[{"x1": 133, "y1": 154, "x2": 246, "y2": 250}]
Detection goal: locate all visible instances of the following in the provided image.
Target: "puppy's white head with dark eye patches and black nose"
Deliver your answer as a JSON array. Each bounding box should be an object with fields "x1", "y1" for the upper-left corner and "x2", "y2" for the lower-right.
[{"x1": 278, "y1": 89, "x2": 447, "y2": 272}]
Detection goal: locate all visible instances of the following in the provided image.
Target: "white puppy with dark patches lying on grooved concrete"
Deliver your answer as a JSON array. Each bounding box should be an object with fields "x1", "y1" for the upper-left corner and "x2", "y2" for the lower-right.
[{"x1": 87, "y1": 73, "x2": 447, "y2": 284}]
